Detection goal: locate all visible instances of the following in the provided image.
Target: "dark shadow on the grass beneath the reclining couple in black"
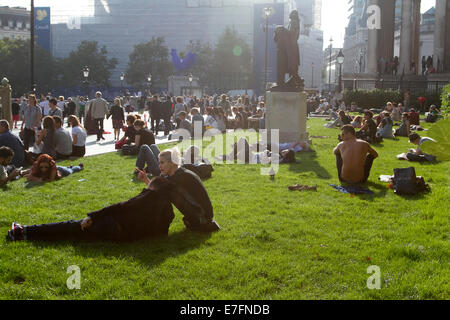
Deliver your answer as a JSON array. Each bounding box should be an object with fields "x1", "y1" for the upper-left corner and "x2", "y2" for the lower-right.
[{"x1": 27, "y1": 229, "x2": 211, "y2": 269}]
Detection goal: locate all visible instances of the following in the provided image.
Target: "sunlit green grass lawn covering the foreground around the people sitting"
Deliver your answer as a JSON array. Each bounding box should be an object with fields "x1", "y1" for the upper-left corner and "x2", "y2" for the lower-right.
[{"x1": 0, "y1": 119, "x2": 450, "y2": 299}]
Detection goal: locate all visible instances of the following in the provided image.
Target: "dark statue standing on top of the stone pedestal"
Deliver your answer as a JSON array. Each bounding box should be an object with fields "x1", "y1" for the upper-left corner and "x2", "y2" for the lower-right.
[{"x1": 270, "y1": 10, "x2": 304, "y2": 92}]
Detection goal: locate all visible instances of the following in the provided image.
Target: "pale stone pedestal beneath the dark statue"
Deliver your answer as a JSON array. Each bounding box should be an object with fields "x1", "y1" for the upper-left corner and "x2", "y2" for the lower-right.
[{"x1": 266, "y1": 92, "x2": 308, "y2": 143}]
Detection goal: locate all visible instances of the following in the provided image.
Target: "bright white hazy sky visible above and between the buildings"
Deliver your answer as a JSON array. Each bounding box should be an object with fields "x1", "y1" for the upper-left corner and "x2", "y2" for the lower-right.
[{"x1": 0, "y1": 0, "x2": 436, "y2": 48}]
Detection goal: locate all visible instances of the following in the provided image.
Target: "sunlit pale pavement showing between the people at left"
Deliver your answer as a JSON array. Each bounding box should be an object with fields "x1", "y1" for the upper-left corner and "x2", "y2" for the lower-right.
[{"x1": 12, "y1": 113, "x2": 176, "y2": 157}]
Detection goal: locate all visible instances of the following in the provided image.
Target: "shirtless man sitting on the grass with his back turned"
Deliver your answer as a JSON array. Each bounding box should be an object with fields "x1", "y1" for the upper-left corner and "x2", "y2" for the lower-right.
[{"x1": 334, "y1": 125, "x2": 378, "y2": 183}]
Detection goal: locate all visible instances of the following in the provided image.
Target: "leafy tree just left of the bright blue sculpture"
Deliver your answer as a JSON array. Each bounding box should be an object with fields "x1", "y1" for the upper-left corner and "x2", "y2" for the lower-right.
[{"x1": 125, "y1": 37, "x2": 173, "y2": 88}]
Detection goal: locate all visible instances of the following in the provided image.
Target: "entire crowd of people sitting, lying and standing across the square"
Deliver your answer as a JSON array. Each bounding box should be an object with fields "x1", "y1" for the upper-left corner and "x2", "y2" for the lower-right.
[{"x1": 0, "y1": 87, "x2": 439, "y2": 241}]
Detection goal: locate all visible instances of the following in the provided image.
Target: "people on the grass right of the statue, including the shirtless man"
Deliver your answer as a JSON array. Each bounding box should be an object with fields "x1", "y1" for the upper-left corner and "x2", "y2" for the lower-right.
[{"x1": 308, "y1": 92, "x2": 441, "y2": 183}]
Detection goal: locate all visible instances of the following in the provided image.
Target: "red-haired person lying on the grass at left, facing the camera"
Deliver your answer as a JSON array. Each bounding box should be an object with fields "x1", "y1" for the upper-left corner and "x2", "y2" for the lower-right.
[{"x1": 22, "y1": 154, "x2": 84, "y2": 182}]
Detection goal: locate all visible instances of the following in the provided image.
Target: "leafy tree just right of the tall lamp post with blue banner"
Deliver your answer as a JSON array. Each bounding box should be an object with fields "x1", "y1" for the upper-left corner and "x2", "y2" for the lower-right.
[{"x1": 59, "y1": 41, "x2": 118, "y2": 87}]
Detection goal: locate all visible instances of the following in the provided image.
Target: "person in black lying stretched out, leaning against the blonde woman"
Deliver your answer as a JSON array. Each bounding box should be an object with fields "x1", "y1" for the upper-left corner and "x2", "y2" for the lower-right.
[{"x1": 6, "y1": 177, "x2": 175, "y2": 242}]
